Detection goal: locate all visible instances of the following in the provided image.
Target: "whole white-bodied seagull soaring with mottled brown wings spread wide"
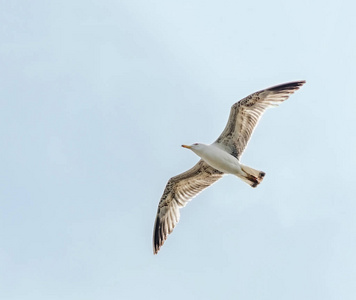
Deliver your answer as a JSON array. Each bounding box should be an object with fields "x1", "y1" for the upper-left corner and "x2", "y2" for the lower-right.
[{"x1": 153, "y1": 80, "x2": 305, "y2": 254}]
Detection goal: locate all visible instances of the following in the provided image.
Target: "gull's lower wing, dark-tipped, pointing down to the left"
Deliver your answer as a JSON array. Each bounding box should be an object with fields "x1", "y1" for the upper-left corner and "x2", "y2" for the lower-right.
[{"x1": 153, "y1": 159, "x2": 224, "y2": 254}]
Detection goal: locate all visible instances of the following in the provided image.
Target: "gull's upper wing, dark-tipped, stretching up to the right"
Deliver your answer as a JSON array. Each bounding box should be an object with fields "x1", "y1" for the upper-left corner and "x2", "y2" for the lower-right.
[{"x1": 215, "y1": 80, "x2": 305, "y2": 159}]
